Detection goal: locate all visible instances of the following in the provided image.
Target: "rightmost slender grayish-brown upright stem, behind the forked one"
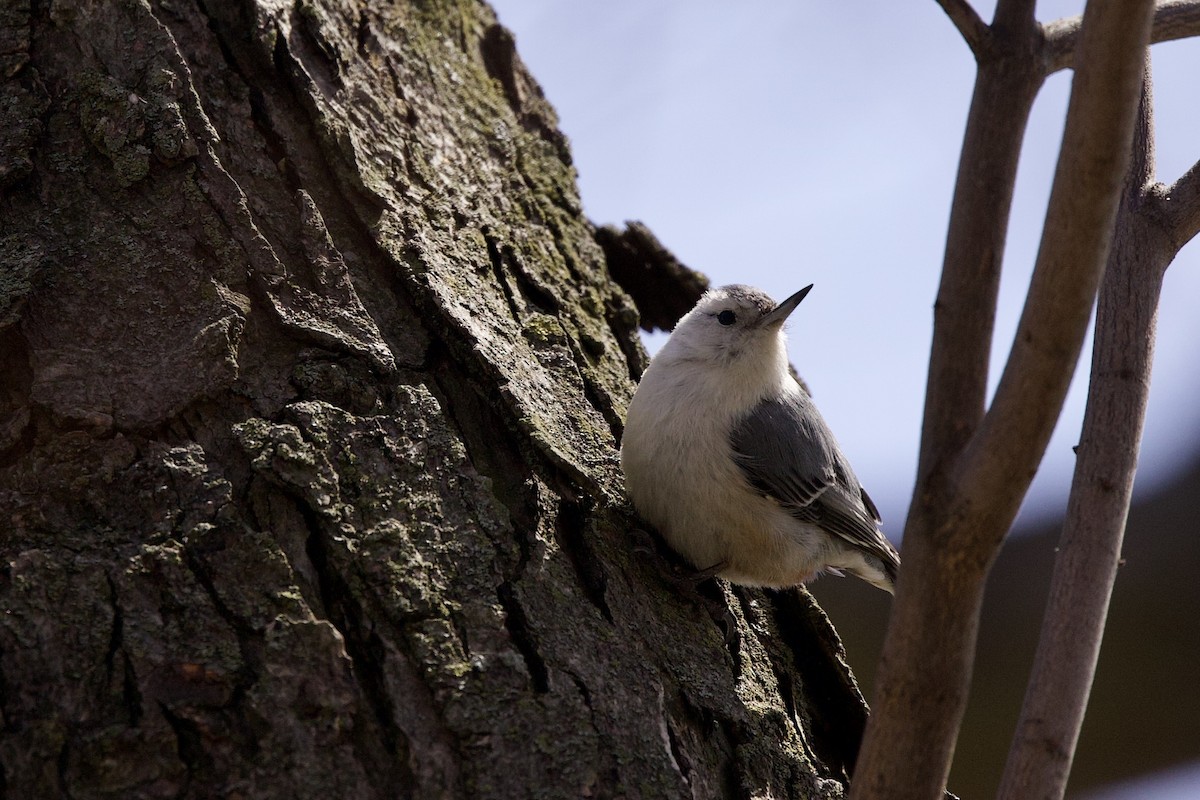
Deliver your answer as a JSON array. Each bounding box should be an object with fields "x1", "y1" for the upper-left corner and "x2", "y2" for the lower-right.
[{"x1": 997, "y1": 64, "x2": 1177, "y2": 800}]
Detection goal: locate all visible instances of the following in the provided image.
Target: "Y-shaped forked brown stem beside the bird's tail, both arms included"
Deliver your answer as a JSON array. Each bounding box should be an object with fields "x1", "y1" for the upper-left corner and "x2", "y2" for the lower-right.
[{"x1": 851, "y1": 0, "x2": 1153, "y2": 800}]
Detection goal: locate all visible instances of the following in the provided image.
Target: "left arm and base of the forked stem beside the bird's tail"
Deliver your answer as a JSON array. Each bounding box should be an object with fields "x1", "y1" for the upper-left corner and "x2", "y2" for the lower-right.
[{"x1": 851, "y1": 9, "x2": 1043, "y2": 798}]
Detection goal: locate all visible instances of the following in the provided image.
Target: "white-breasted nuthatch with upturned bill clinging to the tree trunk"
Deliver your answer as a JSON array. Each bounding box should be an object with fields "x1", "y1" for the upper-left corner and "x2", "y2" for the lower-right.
[{"x1": 620, "y1": 285, "x2": 900, "y2": 593}]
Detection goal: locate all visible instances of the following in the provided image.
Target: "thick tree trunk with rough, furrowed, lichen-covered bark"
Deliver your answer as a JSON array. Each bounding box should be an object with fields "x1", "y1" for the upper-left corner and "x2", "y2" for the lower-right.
[{"x1": 0, "y1": 0, "x2": 865, "y2": 799}]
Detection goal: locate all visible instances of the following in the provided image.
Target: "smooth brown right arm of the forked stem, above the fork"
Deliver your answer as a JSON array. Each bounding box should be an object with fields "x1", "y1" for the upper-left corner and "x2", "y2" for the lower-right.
[{"x1": 960, "y1": 0, "x2": 1153, "y2": 545}]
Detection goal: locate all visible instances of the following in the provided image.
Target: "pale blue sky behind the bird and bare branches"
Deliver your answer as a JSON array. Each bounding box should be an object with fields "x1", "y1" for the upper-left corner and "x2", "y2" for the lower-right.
[{"x1": 480, "y1": 0, "x2": 1200, "y2": 800}]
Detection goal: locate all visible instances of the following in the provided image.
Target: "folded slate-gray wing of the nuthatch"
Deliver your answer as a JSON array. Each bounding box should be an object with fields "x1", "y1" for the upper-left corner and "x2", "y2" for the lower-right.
[{"x1": 730, "y1": 392, "x2": 899, "y2": 576}]
